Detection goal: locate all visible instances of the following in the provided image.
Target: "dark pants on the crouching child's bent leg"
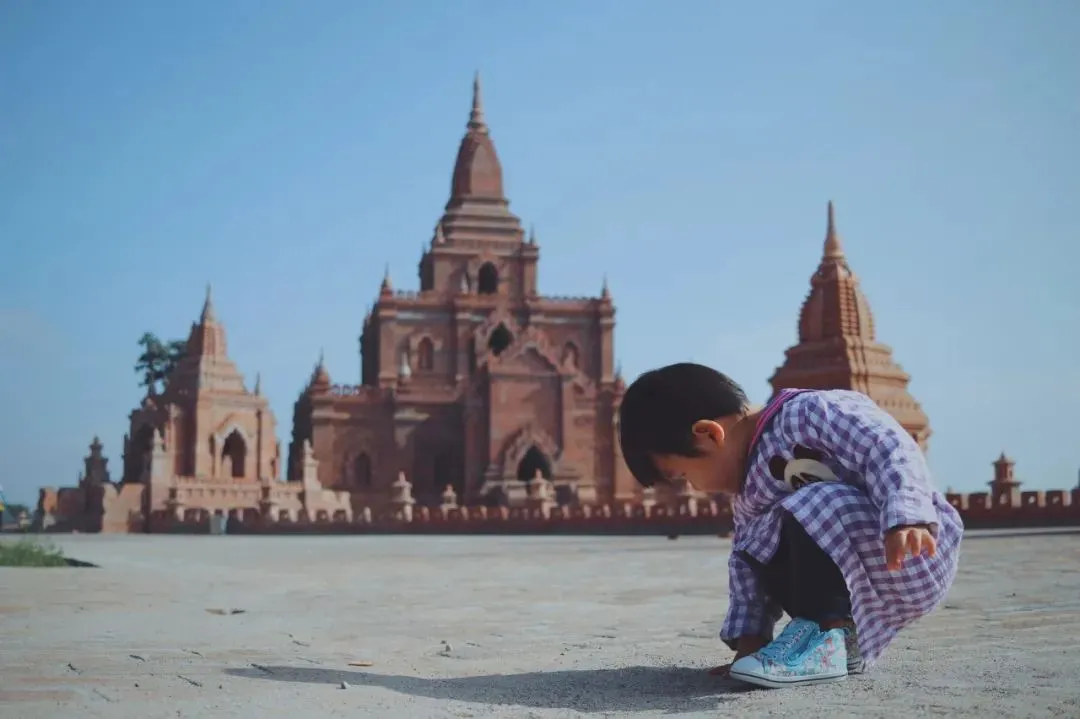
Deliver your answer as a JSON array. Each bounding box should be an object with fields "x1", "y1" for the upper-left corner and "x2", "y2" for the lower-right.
[{"x1": 744, "y1": 512, "x2": 851, "y2": 623}]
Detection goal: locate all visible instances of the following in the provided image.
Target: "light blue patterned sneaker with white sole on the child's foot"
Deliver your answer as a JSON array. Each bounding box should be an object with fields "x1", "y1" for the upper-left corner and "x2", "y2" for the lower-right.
[{"x1": 730, "y1": 619, "x2": 848, "y2": 689}]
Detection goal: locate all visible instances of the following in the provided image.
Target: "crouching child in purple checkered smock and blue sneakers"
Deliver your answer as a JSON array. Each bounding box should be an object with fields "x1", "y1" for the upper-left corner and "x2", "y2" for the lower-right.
[{"x1": 619, "y1": 363, "x2": 963, "y2": 687}]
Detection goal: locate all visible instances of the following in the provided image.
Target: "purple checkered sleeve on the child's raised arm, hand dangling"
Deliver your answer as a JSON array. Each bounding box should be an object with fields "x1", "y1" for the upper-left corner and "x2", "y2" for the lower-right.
[{"x1": 791, "y1": 391, "x2": 937, "y2": 531}]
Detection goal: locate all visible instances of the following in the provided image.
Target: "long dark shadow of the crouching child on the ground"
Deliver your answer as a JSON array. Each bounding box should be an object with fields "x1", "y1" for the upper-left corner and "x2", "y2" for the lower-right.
[{"x1": 226, "y1": 666, "x2": 743, "y2": 711}]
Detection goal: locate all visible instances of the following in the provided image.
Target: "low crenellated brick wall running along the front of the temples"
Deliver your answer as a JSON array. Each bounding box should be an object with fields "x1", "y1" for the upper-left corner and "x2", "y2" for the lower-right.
[{"x1": 35, "y1": 479, "x2": 1080, "y2": 535}]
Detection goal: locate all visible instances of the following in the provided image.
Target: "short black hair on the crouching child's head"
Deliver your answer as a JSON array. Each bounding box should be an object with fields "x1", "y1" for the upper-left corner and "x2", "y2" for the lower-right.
[{"x1": 619, "y1": 362, "x2": 750, "y2": 487}]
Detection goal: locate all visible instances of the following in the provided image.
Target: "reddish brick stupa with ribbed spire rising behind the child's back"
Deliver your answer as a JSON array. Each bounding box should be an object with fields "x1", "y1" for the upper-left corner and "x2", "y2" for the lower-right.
[{"x1": 769, "y1": 202, "x2": 931, "y2": 449}]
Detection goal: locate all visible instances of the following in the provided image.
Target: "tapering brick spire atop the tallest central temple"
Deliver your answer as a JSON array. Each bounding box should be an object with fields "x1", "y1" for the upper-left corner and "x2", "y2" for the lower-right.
[{"x1": 440, "y1": 72, "x2": 525, "y2": 245}]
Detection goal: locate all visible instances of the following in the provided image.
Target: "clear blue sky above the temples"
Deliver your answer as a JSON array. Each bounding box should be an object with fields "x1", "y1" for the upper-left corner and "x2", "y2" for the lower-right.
[{"x1": 0, "y1": 0, "x2": 1080, "y2": 501}]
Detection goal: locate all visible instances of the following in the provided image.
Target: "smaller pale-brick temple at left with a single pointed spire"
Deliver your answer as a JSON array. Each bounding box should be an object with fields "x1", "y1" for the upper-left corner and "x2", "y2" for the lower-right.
[{"x1": 38, "y1": 287, "x2": 365, "y2": 532}]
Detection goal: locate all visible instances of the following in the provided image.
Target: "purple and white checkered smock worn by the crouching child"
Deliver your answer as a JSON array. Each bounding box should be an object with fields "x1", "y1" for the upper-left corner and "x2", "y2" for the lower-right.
[{"x1": 720, "y1": 390, "x2": 963, "y2": 664}]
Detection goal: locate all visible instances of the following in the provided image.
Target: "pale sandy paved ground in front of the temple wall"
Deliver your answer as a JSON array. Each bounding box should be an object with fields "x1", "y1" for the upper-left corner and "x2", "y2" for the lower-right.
[{"x1": 0, "y1": 533, "x2": 1080, "y2": 719}]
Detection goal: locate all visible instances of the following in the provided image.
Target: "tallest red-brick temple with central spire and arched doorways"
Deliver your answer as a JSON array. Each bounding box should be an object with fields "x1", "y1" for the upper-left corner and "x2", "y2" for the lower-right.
[{"x1": 289, "y1": 72, "x2": 634, "y2": 506}]
